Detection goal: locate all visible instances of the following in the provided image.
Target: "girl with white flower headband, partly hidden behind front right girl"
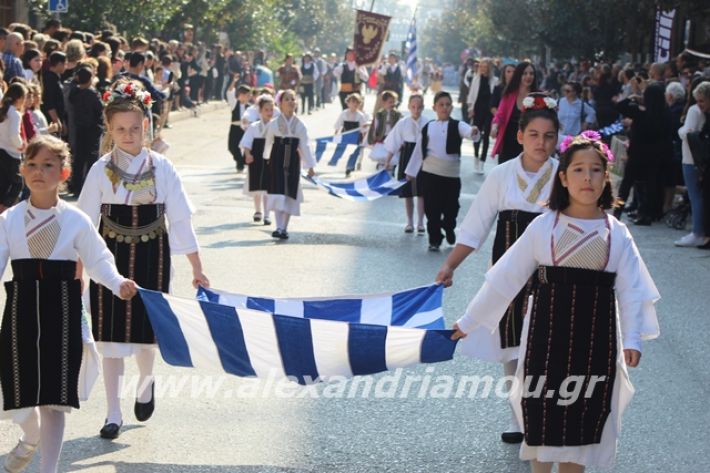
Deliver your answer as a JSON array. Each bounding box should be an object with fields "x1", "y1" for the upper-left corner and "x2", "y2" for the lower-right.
[{"x1": 436, "y1": 94, "x2": 559, "y2": 443}]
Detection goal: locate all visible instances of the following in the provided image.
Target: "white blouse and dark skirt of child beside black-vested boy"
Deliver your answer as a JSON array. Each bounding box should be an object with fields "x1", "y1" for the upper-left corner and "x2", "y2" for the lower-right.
[{"x1": 384, "y1": 116, "x2": 425, "y2": 197}]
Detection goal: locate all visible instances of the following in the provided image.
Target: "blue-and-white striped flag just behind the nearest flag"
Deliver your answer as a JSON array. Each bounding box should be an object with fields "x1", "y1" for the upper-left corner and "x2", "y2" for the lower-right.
[{"x1": 197, "y1": 285, "x2": 445, "y2": 329}]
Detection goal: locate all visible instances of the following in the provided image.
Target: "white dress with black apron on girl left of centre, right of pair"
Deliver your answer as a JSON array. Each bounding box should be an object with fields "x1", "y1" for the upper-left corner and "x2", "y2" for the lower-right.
[{"x1": 264, "y1": 115, "x2": 316, "y2": 218}]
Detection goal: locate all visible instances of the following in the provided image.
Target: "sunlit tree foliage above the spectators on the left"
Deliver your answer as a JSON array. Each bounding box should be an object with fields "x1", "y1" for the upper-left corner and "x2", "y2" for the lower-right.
[{"x1": 31, "y1": 0, "x2": 355, "y2": 60}]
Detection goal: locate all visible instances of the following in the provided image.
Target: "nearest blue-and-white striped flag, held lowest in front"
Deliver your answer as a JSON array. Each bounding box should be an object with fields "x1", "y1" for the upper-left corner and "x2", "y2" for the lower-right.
[{"x1": 139, "y1": 289, "x2": 456, "y2": 385}]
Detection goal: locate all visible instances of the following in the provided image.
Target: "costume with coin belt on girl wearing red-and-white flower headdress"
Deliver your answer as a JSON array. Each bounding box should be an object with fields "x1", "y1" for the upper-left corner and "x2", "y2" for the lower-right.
[{"x1": 78, "y1": 147, "x2": 199, "y2": 358}]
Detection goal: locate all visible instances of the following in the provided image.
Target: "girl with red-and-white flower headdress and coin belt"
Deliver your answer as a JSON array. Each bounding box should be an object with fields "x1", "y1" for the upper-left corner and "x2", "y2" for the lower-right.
[{"x1": 78, "y1": 81, "x2": 209, "y2": 439}]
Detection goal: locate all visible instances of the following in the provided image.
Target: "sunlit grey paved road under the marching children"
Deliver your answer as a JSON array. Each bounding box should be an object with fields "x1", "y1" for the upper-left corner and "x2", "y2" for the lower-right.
[{"x1": 0, "y1": 94, "x2": 710, "y2": 473}]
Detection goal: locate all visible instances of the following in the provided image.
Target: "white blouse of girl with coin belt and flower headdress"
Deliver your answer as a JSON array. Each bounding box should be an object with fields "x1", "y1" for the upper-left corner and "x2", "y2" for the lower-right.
[{"x1": 77, "y1": 148, "x2": 199, "y2": 255}]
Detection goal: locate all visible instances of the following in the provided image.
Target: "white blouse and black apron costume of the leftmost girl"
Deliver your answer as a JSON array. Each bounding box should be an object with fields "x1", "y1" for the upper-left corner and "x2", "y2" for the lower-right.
[{"x1": 0, "y1": 200, "x2": 125, "y2": 416}]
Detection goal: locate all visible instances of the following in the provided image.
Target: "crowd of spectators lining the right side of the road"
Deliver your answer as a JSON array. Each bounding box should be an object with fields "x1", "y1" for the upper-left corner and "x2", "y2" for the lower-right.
[{"x1": 459, "y1": 52, "x2": 710, "y2": 248}]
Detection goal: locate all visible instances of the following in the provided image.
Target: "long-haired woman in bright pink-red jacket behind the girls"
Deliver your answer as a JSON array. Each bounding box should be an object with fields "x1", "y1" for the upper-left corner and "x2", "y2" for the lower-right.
[{"x1": 491, "y1": 61, "x2": 538, "y2": 164}]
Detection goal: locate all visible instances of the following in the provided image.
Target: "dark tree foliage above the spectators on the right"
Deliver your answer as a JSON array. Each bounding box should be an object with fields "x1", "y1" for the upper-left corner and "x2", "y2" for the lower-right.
[{"x1": 422, "y1": 0, "x2": 706, "y2": 61}]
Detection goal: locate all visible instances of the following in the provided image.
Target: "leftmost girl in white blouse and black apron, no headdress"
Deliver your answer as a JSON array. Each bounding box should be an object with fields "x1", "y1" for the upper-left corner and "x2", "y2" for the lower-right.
[{"x1": 0, "y1": 135, "x2": 136, "y2": 473}]
